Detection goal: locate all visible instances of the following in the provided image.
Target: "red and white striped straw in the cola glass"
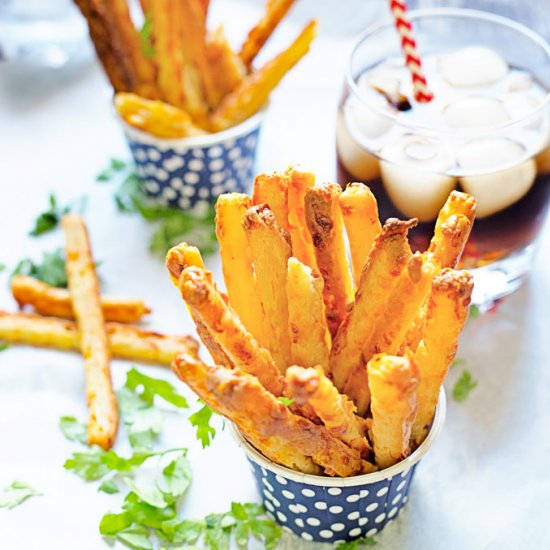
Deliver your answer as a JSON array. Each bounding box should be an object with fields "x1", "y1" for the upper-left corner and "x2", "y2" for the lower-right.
[{"x1": 390, "y1": 0, "x2": 434, "y2": 103}]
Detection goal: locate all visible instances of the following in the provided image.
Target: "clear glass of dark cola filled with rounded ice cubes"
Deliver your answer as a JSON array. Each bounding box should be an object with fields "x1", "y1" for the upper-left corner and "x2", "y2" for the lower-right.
[{"x1": 336, "y1": 8, "x2": 550, "y2": 305}]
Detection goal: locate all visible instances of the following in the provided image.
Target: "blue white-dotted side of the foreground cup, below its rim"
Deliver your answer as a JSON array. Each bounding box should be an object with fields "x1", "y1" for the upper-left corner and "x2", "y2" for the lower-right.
[{"x1": 246, "y1": 461, "x2": 415, "y2": 544}]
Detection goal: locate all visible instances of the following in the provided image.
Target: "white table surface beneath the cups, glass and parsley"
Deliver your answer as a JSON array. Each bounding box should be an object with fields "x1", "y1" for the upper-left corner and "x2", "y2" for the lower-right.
[{"x1": 0, "y1": 3, "x2": 550, "y2": 550}]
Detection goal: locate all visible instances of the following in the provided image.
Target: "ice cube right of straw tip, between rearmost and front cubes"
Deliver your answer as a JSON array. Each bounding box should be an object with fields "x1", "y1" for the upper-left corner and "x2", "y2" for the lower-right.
[{"x1": 443, "y1": 97, "x2": 510, "y2": 128}]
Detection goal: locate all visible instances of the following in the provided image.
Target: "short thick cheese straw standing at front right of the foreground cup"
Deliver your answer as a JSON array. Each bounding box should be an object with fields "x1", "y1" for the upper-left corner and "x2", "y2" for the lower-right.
[{"x1": 367, "y1": 354, "x2": 418, "y2": 468}]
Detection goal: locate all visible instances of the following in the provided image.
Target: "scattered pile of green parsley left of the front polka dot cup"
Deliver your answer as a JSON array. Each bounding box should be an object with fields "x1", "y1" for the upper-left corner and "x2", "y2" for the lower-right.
[{"x1": 60, "y1": 369, "x2": 281, "y2": 550}]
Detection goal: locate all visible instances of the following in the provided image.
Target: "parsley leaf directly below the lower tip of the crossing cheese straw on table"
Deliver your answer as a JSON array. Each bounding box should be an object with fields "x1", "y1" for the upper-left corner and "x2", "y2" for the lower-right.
[{"x1": 64, "y1": 447, "x2": 155, "y2": 481}]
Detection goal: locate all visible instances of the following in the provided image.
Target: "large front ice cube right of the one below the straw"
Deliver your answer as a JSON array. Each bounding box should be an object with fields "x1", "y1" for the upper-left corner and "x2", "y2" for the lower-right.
[{"x1": 457, "y1": 138, "x2": 537, "y2": 218}]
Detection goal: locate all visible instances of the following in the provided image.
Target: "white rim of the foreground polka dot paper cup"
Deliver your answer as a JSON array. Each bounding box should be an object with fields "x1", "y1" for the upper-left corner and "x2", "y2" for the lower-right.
[{"x1": 229, "y1": 388, "x2": 447, "y2": 487}]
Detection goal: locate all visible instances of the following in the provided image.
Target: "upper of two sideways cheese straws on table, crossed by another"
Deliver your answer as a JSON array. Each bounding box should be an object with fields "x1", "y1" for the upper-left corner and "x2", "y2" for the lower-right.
[{"x1": 11, "y1": 275, "x2": 151, "y2": 323}]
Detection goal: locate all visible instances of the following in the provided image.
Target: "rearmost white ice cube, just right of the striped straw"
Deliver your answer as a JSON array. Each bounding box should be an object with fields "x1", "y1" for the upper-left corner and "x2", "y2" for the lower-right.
[{"x1": 439, "y1": 46, "x2": 508, "y2": 88}]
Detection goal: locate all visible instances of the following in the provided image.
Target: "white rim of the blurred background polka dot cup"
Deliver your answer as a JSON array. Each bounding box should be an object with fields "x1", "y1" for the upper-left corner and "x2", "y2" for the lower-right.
[{"x1": 113, "y1": 104, "x2": 269, "y2": 148}]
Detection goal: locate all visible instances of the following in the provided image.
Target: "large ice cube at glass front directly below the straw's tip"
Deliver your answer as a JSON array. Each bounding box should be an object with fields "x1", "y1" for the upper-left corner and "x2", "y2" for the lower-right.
[{"x1": 380, "y1": 134, "x2": 462, "y2": 221}]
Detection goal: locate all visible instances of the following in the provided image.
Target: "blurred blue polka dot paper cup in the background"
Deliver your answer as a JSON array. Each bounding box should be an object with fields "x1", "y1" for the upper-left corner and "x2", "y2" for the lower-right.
[{"x1": 119, "y1": 111, "x2": 264, "y2": 210}]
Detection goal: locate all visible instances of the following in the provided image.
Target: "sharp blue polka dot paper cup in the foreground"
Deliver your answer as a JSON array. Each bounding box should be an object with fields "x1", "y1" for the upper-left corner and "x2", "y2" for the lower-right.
[{"x1": 232, "y1": 390, "x2": 446, "y2": 543}]
